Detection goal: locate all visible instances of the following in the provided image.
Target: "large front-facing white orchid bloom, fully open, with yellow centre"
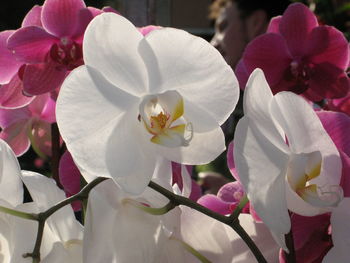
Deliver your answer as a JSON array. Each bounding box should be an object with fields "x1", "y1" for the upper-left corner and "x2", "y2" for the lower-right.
[{"x1": 57, "y1": 13, "x2": 239, "y2": 194}]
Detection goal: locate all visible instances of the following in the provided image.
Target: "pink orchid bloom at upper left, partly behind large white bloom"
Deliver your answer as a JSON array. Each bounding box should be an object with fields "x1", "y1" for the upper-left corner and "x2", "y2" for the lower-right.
[{"x1": 7, "y1": 0, "x2": 116, "y2": 95}]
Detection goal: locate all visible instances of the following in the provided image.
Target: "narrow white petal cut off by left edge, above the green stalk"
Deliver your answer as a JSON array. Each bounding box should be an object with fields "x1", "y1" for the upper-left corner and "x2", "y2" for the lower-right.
[{"x1": 0, "y1": 140, "x2": 23, "y2": 206}]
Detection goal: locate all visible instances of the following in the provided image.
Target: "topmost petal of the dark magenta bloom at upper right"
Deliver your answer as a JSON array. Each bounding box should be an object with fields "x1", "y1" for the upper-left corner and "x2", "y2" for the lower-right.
[{"x1": 279, "y1": 3, "x2": 318, "y2": 57}]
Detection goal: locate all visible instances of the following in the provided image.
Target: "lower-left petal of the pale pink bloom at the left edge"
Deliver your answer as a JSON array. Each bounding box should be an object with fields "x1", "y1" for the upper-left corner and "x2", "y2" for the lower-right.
[{"x1": 0, "y1": 120, "x2": 30, "y2": 156}]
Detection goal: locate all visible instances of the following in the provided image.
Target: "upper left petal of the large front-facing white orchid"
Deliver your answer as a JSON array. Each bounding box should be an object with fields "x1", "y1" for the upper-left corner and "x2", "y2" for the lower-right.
[{"x1": 83, "y1": 13, "x2": 148, "y2": 95}]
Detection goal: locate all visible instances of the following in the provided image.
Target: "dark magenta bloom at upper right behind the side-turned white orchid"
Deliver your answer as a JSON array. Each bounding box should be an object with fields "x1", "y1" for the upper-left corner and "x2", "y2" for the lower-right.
[{"x1": 236, "y1": 3, "x2": 350, "y2": 101}]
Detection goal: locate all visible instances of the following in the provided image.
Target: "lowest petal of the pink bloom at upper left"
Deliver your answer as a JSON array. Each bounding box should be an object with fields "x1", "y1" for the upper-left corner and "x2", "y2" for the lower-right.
[{"x1": 23, "y1": 61, "x2": 69, "y2": 95}]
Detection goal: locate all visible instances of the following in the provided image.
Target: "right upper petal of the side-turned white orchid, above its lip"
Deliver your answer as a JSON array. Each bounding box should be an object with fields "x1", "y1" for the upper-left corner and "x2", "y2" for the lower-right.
[{"x1": 271, "y1": 92, "x2": 342, "y2": 194}]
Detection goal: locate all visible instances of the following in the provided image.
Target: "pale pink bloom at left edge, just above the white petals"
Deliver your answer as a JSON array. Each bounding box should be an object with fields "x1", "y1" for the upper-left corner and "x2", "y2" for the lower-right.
[{"x1": 0, "y1": 94, "x2": 56, "y2": 157}]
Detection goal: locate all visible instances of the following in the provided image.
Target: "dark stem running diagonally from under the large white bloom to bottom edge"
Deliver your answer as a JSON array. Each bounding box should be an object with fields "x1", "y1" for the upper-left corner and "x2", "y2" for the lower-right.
[{"x1": 148, "y1": 181, "x2": 267, "y2": 263}]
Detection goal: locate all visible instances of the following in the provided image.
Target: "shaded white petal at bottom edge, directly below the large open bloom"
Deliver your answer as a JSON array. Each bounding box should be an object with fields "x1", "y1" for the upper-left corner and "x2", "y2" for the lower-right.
[{"x1": 83, "y1": 180, "x2": 160, "y2": 263}]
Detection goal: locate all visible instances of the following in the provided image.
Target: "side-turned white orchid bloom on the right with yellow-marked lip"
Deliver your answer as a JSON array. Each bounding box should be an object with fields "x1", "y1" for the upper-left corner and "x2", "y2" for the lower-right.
[{"x1": 234, "y1": 69, "x2": 342, "y2": 250}]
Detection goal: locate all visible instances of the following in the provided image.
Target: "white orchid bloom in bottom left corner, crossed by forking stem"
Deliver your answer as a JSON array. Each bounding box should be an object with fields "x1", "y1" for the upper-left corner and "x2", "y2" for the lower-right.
[{"x1": 0, "y1": 140, "x2": 83, "y2": 263}]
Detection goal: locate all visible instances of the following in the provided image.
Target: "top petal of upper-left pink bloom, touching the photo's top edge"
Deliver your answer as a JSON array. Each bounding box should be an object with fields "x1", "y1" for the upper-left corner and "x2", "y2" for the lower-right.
[{"x1": 41, "y1": 0, "x2": 86, "y2": 37}]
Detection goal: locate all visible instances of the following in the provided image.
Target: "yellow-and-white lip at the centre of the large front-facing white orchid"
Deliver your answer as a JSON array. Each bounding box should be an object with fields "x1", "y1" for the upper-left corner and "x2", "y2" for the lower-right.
[{"x1": 139, "y1": 90, "x2": 193, "y2": 148}]
